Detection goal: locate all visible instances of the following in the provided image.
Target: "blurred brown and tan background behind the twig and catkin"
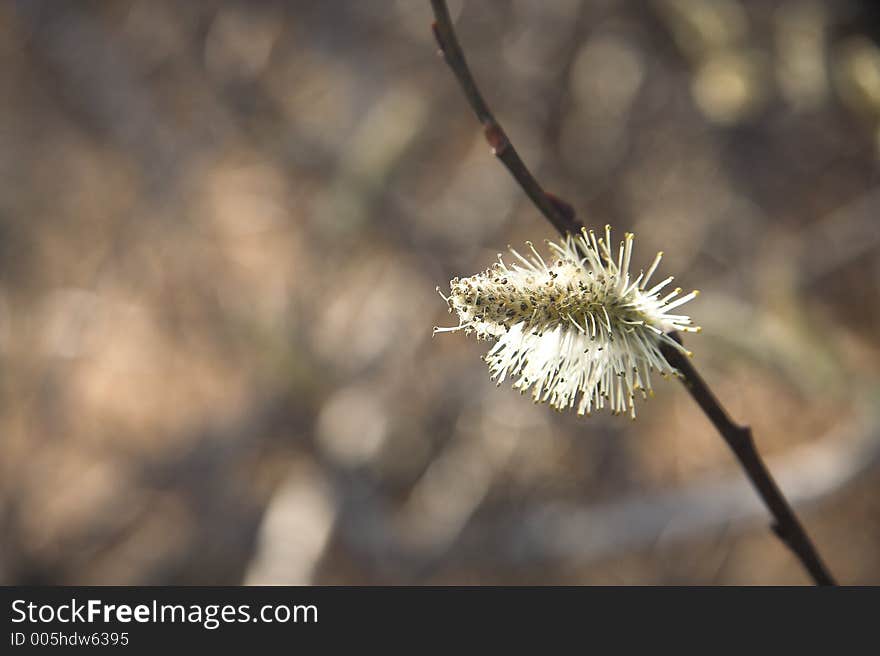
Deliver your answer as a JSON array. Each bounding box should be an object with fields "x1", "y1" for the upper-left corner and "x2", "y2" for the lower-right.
[{"x1": 0, "y1": 0, "x2": 880, "y2": 584}]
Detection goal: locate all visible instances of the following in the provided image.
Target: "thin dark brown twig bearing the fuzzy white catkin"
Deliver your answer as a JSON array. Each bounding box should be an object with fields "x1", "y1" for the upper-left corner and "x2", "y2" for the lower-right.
[{"x1": 431, "y1": 0, "x2": 835, "y2": 585}]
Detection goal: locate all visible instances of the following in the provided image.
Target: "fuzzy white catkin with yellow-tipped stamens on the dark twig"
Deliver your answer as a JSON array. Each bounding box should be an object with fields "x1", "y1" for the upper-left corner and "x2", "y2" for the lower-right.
[{"x1": 434, "y1": 226, "x2": 700, "y2": 418}]
